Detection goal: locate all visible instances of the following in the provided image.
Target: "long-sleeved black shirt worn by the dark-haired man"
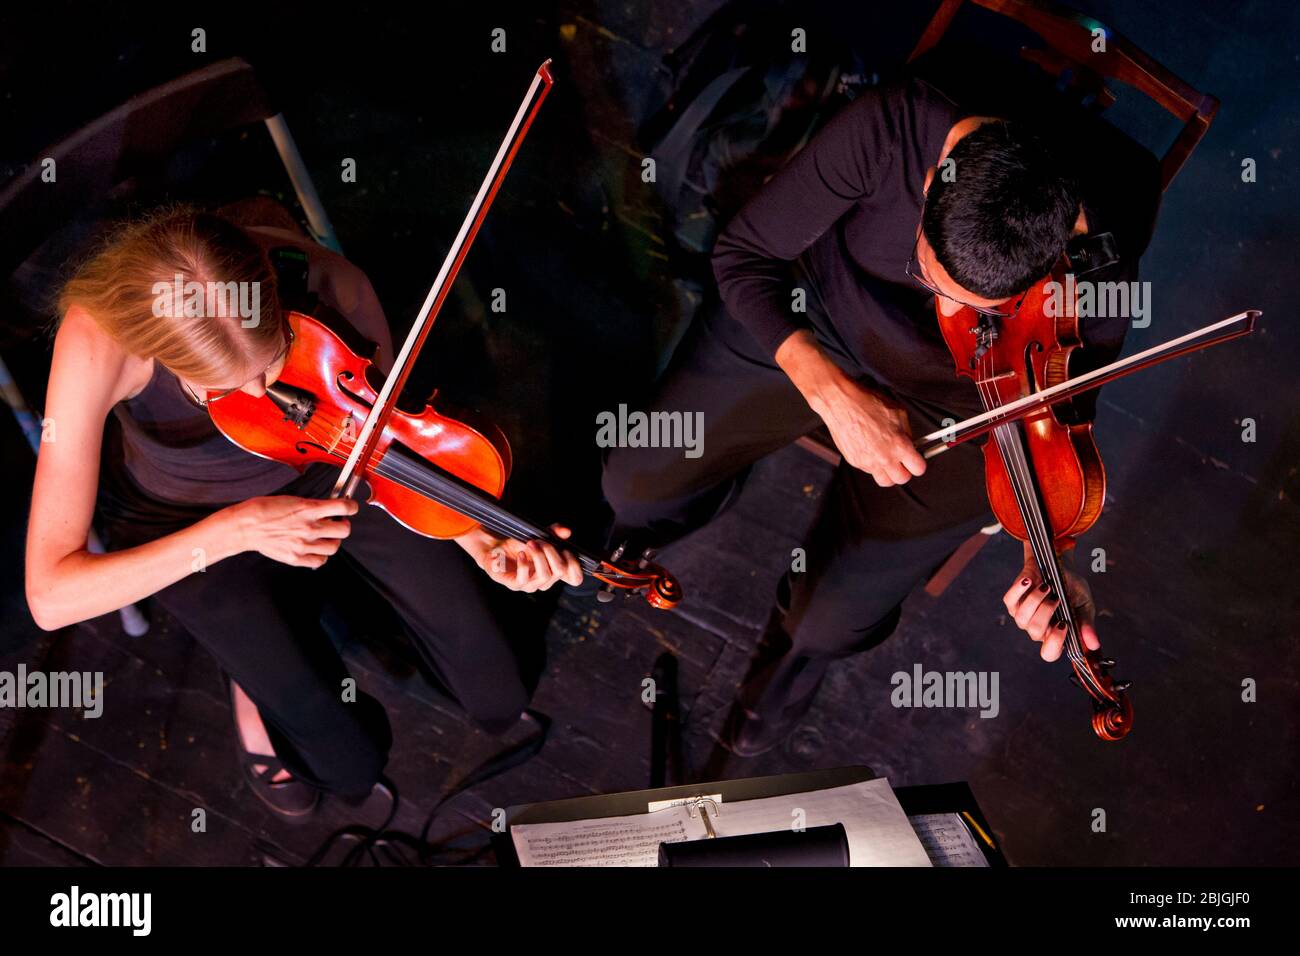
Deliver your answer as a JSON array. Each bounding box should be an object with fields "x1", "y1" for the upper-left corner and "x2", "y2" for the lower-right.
[{"x1": 714, "y1": 77, "x2": 1136, "y2": 416}]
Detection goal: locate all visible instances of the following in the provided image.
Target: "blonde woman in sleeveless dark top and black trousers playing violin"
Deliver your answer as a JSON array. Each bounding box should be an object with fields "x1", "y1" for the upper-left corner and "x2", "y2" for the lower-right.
[{"x1": 26, "y1": 208, "x2": 581, "y2": 817}]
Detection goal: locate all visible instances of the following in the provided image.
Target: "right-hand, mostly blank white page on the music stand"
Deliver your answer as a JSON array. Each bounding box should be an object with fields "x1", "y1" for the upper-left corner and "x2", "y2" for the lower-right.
[{"x1": 710, "y1": 778, "x2": 931, "y2": 866}]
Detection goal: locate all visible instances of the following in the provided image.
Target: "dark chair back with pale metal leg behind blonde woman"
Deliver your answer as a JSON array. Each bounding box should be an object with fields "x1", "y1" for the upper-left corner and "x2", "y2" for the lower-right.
[{"x1": 0, "y1": 57, "x2": 351, "y2": 401}]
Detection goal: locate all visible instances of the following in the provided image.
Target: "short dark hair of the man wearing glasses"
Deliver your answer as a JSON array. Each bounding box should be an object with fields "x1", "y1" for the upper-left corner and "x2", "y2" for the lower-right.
[{"x1": 920, "y1": 120, "x2": 1079, "y2": 299}]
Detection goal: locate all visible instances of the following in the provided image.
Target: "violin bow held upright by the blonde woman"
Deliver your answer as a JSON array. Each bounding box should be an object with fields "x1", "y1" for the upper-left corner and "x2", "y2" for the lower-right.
[{"x1": 329, "y1": 60, "x2": 555, "y2": 498}]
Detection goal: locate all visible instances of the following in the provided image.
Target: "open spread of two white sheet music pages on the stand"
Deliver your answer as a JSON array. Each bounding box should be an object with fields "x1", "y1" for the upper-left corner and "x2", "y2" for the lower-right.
[{"x1": 511, "y1": 779, "x2": 931, "y2": 866}]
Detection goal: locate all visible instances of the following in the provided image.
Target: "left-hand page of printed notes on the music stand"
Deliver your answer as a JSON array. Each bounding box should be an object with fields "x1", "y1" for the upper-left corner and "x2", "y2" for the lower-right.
[{"x1": 510, "y1": 806, "x2": 706, "y2": 866}]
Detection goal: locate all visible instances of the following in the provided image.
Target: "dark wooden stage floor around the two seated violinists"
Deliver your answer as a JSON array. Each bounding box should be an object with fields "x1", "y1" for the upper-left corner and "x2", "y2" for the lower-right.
[{"x1": 0, "y1": 0, "x2": 1300, "y2": 865}]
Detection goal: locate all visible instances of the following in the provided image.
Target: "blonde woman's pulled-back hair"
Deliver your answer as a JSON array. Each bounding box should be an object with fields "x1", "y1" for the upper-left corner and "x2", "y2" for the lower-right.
[{"x1": 57, "y1": 206, "x2": 283, "y2": 385}]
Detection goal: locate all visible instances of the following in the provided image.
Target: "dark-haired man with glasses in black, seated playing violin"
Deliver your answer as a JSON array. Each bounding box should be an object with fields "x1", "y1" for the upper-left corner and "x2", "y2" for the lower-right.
[{"x1": 605, "y1": 79, "x2": 1140, "y2": 756}]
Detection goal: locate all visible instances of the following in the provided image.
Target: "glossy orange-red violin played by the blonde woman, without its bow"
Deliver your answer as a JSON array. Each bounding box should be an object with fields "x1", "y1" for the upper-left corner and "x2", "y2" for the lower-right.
[{"x1": 208, "y1": 307, "x2": 681, "y2": 609}]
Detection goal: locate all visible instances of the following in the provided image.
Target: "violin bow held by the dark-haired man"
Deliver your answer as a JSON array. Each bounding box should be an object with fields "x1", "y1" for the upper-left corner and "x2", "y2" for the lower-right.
[{"x1": 917, "y1": 308, "x2": 1264, "y2": 458}]
